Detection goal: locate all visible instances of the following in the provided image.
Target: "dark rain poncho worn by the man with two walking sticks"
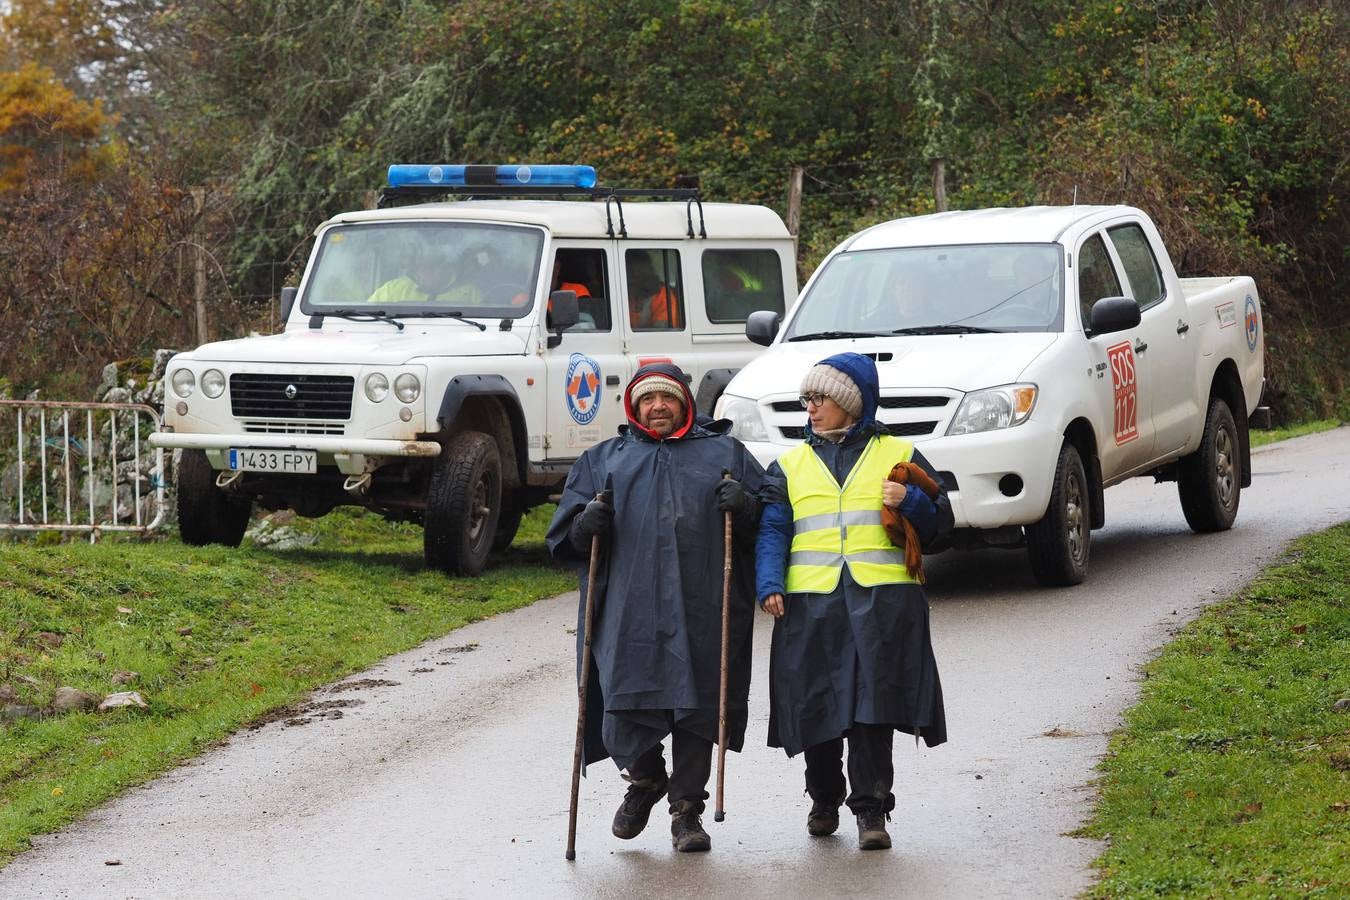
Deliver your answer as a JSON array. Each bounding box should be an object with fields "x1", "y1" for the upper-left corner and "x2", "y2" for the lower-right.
[{"x1": 547, "y1": 364, "x2": 764, "y2": 769}]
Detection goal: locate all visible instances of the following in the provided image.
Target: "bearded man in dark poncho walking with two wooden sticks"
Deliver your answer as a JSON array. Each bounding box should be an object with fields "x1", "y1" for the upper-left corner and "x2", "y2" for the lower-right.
[{"x1": 547, "y1": 364, "x2": 764, "y2": 853}]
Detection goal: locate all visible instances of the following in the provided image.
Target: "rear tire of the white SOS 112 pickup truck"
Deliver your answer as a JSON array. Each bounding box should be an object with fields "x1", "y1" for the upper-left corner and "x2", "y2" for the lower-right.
[{"x1": 1177, "y1": 397, "x2": 1242, "y2": 534}]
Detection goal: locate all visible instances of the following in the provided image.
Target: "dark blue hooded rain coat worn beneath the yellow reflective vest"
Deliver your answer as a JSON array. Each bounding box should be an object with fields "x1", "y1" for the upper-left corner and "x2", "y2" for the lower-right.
[{"x1": 756, "y1": 354, "x2": 952, "y2": 756}]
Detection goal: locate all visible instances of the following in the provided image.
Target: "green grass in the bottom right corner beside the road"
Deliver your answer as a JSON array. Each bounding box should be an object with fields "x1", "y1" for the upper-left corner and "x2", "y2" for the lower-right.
[{"x1": 1083, "y1": 522, "x2": 1350, "y2": 897}]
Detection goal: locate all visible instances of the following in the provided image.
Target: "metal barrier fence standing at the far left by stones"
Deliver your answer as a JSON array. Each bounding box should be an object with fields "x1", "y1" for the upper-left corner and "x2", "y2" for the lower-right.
[{"x1": 0, "y1": 399, "x2": 169, "y2": 541}]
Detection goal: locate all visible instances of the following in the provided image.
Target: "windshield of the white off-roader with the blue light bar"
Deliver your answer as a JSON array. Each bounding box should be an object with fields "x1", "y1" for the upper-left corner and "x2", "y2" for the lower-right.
[{"x1": 300, "y1": 221, "x2": 544, "y2": 318}]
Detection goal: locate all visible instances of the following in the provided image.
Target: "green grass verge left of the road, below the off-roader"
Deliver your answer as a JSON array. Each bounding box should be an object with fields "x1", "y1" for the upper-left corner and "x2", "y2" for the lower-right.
[{"x1": 0, "y1": 506, "x2": 575, "y2": 865}]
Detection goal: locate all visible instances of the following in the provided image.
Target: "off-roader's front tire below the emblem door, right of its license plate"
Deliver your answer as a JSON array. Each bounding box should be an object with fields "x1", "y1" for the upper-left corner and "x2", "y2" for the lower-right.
[{"x1": 423, "y1": 432, "x2": 502, "y2": 575}]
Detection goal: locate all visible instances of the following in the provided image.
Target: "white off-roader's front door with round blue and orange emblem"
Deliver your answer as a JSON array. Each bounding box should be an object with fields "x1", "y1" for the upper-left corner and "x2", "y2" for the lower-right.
[{"x1": 544, "y1": 242, "x2": 629, "y2": 460}]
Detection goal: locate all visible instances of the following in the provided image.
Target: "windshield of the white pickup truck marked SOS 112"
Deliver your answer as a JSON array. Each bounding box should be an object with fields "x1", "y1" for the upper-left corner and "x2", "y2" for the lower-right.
[{"x1": 784, "y1": 244, "x2": 1064, "y2": 340}]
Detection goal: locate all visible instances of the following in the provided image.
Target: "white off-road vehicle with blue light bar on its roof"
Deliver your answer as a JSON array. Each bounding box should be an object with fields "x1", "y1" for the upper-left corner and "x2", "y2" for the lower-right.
[{"x1": 150, "y1": 166, "x2": 797, "y2": 573}]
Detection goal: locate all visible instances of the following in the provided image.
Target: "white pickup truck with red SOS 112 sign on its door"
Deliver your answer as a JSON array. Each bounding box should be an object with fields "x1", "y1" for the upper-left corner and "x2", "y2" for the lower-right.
[{"x1": 717, "y1": 206, "x2": 1264, "y2": 584}]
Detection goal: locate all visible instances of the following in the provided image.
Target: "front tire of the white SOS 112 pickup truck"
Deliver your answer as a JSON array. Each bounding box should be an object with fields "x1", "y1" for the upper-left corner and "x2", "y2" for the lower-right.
[{"x1": 1025, "y1": 441, "x2": 1092, "y2": 587}]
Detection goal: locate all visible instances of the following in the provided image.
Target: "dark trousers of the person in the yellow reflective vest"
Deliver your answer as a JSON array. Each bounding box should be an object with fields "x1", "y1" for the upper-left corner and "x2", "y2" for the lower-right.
[{"x1": 805, "y1": 722, "x2": 895, "y2": 815}]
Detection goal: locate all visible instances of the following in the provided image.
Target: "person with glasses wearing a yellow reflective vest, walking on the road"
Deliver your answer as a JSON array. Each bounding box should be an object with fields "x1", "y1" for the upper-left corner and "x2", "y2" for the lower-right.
[{"x1": 756, "y1": 354, "x2": 952, "y2": 850}]
